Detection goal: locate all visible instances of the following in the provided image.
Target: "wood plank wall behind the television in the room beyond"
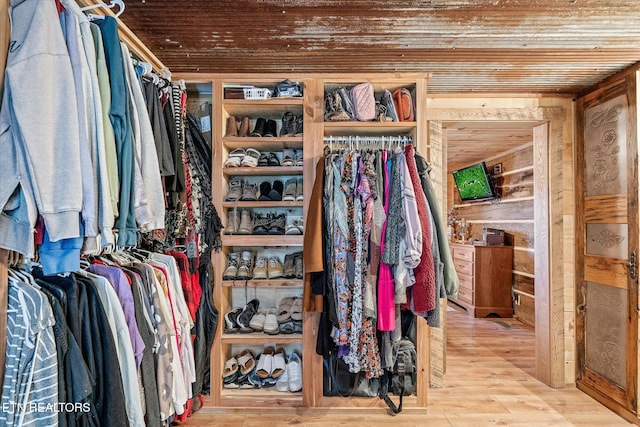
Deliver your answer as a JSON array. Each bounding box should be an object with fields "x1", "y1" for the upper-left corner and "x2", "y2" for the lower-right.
[{"x1": 447, "y1": 142, "x2": 535, "y2": 326}]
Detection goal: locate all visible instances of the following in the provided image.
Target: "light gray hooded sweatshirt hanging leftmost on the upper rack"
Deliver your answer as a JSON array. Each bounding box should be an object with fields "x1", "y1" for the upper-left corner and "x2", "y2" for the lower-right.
[{"x1": 0, "y1": 0, "x2": 82, "y2": 257}]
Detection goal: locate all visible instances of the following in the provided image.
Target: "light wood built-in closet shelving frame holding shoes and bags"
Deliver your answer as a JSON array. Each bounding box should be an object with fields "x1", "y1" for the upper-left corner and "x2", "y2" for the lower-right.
[{"x1": 177, "y1": 73, "x2": 429, "y2": 410}]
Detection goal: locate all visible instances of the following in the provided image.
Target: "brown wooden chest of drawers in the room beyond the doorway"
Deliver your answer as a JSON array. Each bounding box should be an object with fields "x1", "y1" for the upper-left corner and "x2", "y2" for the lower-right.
[{"x1": 450, "y1": 243, "x2": 513, "y2": 317}]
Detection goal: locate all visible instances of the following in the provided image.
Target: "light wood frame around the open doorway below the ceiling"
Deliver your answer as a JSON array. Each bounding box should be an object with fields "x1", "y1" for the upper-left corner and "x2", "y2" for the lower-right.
[{"x1": 427, "y1": 107, "x2": 573, "y2": 387}]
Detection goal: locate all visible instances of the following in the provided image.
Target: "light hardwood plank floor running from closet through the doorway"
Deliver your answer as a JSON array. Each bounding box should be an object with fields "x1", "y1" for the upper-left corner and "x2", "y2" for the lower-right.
[{"x1": 187, "y1": 310, "x2": 632, "y2": 427}]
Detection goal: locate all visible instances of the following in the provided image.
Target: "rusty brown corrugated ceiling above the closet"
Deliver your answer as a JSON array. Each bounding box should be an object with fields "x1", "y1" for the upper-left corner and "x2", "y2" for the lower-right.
[{"x1": 120, "y1": 0, "x2": 640, "y2": 94}]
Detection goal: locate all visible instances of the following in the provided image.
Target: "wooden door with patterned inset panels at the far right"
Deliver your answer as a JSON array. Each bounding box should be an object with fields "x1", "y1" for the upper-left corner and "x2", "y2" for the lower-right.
[{"x1": 576, "y1": 77, "x2": 638, "y2": 418}]
